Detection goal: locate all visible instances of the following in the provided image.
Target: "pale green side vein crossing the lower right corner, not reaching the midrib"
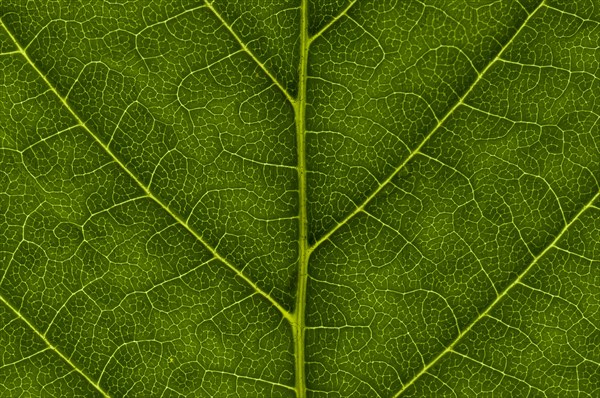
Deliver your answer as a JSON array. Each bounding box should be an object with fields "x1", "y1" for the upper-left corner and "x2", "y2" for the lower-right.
[{"x1": 394, "y1": 191, "x2": 600, "y2": 398}]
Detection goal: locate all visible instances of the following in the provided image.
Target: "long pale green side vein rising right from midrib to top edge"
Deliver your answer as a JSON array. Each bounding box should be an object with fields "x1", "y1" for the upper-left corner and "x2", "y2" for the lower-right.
[{"x1": 309, "y1": 1, "x2": 544, "y2": 252}]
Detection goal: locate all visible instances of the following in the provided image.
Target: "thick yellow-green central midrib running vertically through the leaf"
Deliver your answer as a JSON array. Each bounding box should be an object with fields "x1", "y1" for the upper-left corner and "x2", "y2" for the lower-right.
[{"x1": 292, "y1": 0, "x2": 310, "y2": 398}]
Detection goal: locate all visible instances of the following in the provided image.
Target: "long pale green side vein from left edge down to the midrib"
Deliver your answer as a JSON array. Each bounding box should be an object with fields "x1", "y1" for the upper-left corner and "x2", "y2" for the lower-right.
[{"x1": 0, "y1": 21, "x2": 292, "y2": 322}]
